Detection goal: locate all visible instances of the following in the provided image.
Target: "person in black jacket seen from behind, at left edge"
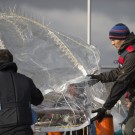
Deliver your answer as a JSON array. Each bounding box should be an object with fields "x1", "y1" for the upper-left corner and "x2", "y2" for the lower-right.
[{"x1": 0, "y1": 49, "x2": 43, "y2": 135}]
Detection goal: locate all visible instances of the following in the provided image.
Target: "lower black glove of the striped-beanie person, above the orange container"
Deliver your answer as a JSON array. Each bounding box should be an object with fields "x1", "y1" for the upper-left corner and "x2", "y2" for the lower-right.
[{"x1": 91, "y1": 107, "x2": 107, "y2": 122}]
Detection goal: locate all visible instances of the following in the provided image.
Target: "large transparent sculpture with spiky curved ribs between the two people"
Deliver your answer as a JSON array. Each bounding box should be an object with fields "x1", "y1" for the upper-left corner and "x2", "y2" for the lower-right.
[{"x1": 0, "y1": 12, "x2": 104, "y2": 132}]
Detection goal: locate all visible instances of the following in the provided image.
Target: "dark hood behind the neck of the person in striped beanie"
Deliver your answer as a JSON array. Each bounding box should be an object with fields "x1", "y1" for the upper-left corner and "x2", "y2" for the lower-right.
[{"x1": 118, "y1": 32, "x2": 135, "y2": 55}]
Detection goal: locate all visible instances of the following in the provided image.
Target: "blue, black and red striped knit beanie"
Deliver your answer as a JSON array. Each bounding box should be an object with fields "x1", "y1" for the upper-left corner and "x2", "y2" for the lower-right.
[{"x1": 109, "y1": 23, "x2": 130, "y2": 40}]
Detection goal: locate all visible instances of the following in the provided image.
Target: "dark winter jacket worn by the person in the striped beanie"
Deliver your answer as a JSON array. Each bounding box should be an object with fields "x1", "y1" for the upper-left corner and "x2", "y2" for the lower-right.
[{"x1": 99, "y1": 33, "x2": 135, "y2": 109}]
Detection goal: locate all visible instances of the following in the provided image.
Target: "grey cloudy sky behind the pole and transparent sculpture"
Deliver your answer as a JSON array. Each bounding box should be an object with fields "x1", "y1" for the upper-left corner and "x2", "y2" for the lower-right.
[{"x1": 0, "y1": 0, "x2": 135, "y2": 66}]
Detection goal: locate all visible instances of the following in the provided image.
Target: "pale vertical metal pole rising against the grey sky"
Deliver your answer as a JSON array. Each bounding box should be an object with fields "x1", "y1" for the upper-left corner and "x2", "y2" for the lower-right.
[{"x1": 87, "y1": 0, "x2": 91, "y2": 45}]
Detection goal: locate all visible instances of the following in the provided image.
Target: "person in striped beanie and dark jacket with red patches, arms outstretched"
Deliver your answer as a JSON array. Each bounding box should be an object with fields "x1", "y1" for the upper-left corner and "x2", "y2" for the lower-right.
[{"x1": 88, "y1": 23, "x2": 135, "y2": 135}]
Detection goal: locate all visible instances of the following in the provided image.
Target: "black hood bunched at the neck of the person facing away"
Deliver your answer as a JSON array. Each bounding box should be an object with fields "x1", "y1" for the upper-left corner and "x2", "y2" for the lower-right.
[{"x1": 0, "y1": 62, "x2": 17, "y2": 72}]
